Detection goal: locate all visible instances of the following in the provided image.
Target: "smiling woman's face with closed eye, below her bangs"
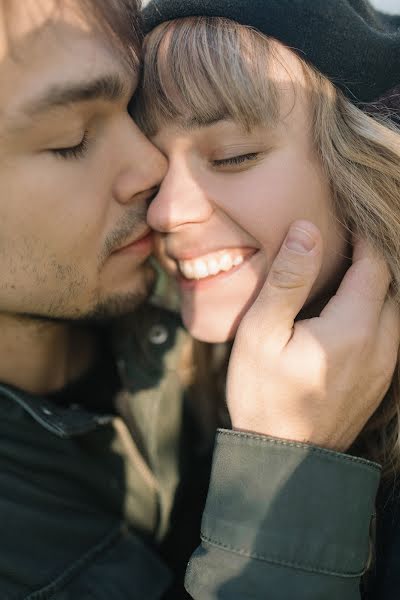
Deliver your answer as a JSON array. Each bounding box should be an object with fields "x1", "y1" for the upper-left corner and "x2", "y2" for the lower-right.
[{"x1": 148, "y1": 45, "x2": 346, "y2": 342}]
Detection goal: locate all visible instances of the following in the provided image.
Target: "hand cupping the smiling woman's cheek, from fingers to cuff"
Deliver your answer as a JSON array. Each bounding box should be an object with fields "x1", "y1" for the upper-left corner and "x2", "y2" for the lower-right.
[{"x1": 227, "y1": 221, "x2": 400, "y2": 451}]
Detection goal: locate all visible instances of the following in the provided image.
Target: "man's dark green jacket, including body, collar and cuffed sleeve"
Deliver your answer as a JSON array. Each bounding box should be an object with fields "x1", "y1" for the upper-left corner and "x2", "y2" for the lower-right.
[{"x1": 0, "y1": 308, "x2": 379, "y2": 600}]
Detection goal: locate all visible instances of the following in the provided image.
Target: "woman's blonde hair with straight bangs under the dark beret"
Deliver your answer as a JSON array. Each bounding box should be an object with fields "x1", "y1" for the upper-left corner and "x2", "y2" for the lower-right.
[{"x1": 133, "y1": 17, "x2": 400, "y2": 475}]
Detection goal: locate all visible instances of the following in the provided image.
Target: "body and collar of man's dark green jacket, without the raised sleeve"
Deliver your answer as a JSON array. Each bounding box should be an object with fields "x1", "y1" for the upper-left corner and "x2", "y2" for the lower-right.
[{"x1": 0, "y1": 308, "x2": 199, "y2": 600}]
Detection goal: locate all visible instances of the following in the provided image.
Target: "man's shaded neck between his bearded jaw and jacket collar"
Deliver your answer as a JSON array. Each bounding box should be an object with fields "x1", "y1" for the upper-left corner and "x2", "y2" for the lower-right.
[{"x1": 0, "y1": 315, "x2": 95, "y2": 394}]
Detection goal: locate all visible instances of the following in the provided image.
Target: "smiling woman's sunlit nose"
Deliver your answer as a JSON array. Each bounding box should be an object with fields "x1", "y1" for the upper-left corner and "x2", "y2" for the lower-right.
[{"x1": 147, "y1": 162, "x2": 214, "y2": 233}]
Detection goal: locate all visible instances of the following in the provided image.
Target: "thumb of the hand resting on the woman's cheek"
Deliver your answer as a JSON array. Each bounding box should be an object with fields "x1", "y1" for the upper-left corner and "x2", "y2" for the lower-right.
[{"x1": 254, "y1": 221, "x2": 322, "y2": 336}]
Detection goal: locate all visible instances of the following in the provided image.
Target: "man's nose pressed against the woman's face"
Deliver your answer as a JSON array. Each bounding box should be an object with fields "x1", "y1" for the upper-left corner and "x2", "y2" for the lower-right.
[{"x1": 113, "y1": 115, "x2": 167, "y2": 204}]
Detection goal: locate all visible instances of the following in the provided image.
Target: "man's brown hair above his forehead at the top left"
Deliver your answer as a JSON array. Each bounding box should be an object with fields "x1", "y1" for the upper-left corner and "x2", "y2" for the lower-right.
[{"x1": 0, "y1": 0, "x2": 143, "y2": 69}]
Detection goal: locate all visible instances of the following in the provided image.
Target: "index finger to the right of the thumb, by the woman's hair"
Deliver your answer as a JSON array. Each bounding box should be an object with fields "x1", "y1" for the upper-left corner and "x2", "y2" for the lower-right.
[{"x1": 321, "y1": 238, "x2": 391, "y2": 325}]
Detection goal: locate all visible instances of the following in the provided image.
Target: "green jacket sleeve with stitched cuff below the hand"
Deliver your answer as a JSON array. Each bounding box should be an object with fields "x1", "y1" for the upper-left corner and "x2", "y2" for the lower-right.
[{"x1": 185, "y1": 430, "x2": 380, "y2": 600}]
